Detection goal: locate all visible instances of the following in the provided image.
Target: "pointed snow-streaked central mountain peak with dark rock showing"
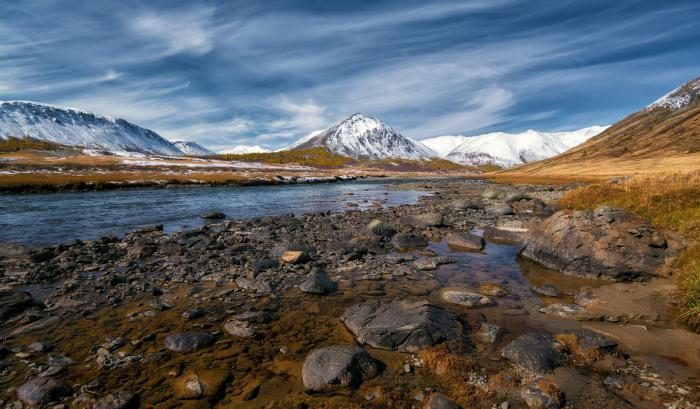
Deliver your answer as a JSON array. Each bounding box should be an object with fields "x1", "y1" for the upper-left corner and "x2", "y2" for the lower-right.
[{"x1": 289, "y1": 114, "x2": 437, "y2": 160}]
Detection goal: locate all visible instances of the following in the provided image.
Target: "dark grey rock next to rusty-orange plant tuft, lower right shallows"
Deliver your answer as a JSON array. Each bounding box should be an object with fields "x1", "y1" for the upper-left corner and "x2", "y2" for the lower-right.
[{"x1": 501, "y1": 332, "x2": 562, "y2": 373}]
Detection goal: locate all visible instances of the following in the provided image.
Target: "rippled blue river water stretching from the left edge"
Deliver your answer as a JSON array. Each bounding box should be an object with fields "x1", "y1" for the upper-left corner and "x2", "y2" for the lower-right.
[{"x1": 0, "y1": 180, "x2": 454, "y2": 244}]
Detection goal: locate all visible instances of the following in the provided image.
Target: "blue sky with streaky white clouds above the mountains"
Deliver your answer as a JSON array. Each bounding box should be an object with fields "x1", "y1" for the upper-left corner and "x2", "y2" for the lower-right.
[{"x1": 0, "y1": 0, "x2": 700, "y2": 149}]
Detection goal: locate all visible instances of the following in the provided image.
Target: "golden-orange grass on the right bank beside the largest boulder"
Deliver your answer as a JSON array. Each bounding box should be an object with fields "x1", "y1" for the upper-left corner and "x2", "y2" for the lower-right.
[{"x1": 559, "y1": 171, "x2": 700, "y2": 331}]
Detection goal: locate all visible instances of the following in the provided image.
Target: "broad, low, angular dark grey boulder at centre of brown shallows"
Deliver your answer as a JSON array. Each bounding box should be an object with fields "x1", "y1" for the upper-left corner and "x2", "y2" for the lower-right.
[{"x1": 341, "y1": 300, "x2": 458, "y2": 352}]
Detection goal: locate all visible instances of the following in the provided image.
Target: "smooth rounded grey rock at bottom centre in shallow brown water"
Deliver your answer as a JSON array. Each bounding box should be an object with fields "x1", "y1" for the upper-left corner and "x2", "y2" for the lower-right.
[{"x1": 301, "y1": 345, "x2": 379, "y2": 392}]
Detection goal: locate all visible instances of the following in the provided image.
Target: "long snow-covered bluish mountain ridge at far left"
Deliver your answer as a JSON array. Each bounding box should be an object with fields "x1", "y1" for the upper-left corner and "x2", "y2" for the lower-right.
[{"x1": 0, "y1": 101, "x2": 182, "y2": 155}]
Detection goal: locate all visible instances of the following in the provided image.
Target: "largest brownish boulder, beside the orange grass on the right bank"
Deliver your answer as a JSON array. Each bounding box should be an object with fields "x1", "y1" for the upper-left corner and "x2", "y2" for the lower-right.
[{"x1": 521, "y1": 206, "x2": 669, "y2": 280}]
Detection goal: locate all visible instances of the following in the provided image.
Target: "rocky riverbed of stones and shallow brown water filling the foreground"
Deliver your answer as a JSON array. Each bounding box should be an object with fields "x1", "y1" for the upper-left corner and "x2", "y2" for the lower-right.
[{"x1": 0, "y1": 181, "x2": 700, "y2": 409}]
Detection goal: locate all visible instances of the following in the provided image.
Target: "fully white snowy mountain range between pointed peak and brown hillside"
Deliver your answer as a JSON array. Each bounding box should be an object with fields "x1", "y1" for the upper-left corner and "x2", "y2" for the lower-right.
[{"x1": 445, "y1": 126, "x2": 608, "y2": 168}]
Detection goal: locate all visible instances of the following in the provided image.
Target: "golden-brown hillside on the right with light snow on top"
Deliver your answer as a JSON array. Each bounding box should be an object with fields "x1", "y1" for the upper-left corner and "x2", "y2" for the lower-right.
[{"x1": 508, "y1": 77, "x2": 700, "y2": 173}]
